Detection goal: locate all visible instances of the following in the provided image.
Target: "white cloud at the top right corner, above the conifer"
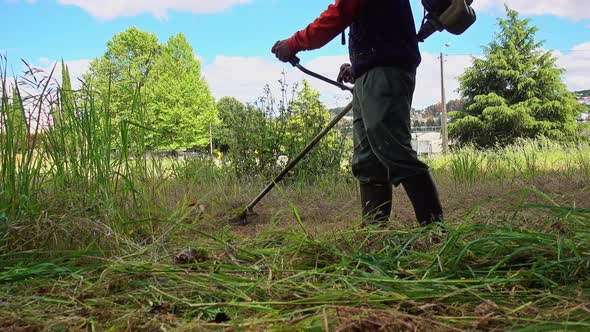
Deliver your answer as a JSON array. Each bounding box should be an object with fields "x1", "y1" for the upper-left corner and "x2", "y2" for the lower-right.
[{"x1": 473, "y1": 0, "x2": 590, "y2": 21}]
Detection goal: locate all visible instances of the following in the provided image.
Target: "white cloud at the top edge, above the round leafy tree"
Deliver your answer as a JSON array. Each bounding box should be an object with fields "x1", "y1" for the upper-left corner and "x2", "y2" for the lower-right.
[{"x1": 58, "y1": 0, "x2": 254, "y2": 20}]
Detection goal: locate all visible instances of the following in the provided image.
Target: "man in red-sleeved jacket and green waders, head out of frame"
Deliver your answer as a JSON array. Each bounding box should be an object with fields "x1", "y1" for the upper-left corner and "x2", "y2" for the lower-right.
[{"x1": 272, "y1": 0, "x2": 443, "y2": 225}]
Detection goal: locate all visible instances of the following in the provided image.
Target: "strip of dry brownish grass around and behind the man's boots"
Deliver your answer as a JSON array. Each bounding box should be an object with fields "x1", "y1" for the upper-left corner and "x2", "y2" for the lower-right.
[{"x1": 192, "y1": 172, "x2": 590, "y2": 238}]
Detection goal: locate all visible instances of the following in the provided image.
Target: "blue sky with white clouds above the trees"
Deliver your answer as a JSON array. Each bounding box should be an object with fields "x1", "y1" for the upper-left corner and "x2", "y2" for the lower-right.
[{"x1": 0, "y1": 0, "x2": 590, "y2": 108}]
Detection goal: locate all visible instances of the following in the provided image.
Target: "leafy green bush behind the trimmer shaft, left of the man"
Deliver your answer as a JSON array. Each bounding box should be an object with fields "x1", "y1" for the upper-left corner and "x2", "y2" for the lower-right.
[{"x1": 216, "y1": 81, "x2": 350, "y2": 176}]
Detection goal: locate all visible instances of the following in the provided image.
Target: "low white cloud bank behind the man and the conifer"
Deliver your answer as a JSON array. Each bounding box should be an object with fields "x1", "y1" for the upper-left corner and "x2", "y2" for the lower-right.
[{"x1": 203, "y1": 42, "x2": 590, "y2": 109}]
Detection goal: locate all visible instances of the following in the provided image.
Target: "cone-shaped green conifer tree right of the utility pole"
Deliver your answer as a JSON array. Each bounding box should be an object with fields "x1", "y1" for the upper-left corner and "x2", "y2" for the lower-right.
[{"x1": 449, "y1": 7, "x2": 581, "y2": 147}]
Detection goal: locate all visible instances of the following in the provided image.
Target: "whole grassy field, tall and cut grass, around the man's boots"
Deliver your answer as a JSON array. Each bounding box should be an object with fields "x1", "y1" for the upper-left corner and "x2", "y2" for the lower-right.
[{"x1": 0, "y1": 66, "x2": 590, "y2": 331}]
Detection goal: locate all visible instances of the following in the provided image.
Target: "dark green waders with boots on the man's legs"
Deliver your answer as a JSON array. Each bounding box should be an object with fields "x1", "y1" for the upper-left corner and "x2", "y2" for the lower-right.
[{"x1": 352, "y1": 67, "x2": 443, "y2": 225}]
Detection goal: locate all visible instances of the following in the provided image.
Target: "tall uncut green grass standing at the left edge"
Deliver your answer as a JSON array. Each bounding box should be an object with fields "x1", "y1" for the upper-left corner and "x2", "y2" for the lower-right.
[{"x1": 0, "y1": 59, "x2": 220, "y2": 251}]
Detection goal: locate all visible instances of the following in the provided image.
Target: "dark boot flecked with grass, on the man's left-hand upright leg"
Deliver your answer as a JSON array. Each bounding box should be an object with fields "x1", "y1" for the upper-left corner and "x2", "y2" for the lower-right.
[{"x1": 360, "y1": 183, "x2": 393, "y2": 226}]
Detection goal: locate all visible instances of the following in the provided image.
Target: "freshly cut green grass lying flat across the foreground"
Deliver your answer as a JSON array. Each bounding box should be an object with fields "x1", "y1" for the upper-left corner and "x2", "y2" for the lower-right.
[{"x1": 0, "y1": 182, "x2": 590, "y2": 331}]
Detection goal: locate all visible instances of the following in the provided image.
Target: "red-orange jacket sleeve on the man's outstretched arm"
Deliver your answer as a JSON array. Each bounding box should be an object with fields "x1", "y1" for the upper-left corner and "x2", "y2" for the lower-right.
[{"x1": 287, "y1": 0, "x2": 369, "y2": 53}]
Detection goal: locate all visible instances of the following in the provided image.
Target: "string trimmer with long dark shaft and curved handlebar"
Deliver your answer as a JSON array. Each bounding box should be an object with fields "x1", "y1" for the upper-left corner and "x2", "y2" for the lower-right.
[{"x1": 231, "y1": 57, "x2": 353, "y2": 225}]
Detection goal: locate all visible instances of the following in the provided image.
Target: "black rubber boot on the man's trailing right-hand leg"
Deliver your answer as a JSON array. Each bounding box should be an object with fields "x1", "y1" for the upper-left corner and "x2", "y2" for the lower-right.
[{"x1": 402, "y1": 171, "x2": 443, "y2": 226}]
